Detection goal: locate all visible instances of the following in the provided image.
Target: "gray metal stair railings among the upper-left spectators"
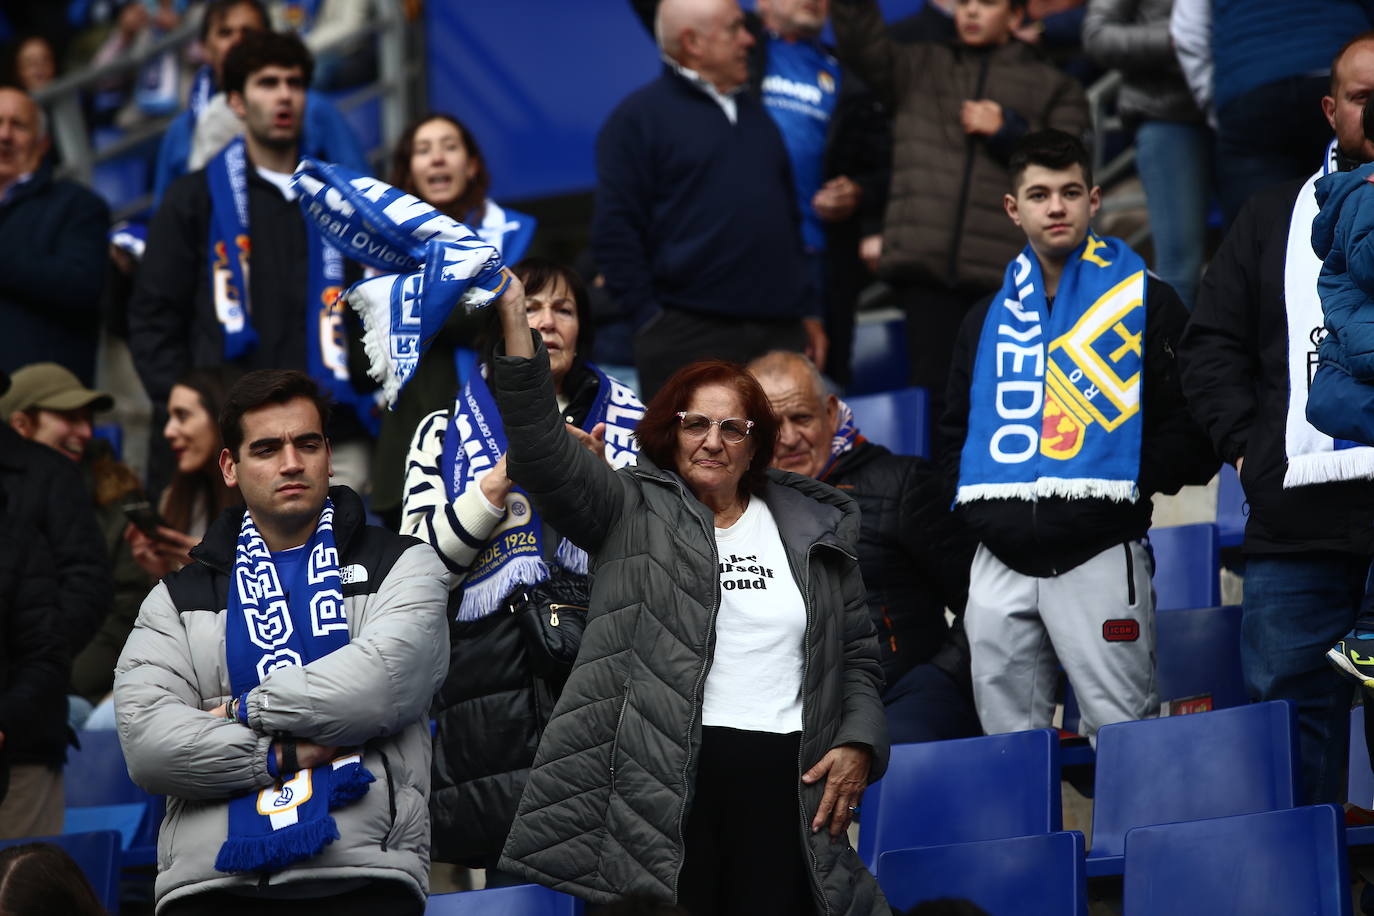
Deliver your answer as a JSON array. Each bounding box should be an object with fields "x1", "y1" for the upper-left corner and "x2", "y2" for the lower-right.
[{"x1": 33, "y1": 0, "x2": 409, "y2": 211}]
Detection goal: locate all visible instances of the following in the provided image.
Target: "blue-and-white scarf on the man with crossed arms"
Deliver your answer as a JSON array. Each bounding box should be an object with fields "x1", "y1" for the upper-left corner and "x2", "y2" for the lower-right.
[{"x1": 214, "y1": 500, "x2": 374, "y2": 872}]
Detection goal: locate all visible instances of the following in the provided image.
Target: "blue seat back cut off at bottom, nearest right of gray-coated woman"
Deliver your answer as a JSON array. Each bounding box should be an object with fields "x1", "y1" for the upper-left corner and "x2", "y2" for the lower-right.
[{"x1": 879, "y1": 831, "x2": 1088, "y2": 916}]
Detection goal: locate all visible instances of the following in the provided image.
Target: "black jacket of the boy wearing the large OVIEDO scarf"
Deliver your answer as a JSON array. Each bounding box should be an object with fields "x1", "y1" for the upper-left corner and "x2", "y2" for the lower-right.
[{"x1": 940, "y1": 276, "x2": 1220, "y2": 577}]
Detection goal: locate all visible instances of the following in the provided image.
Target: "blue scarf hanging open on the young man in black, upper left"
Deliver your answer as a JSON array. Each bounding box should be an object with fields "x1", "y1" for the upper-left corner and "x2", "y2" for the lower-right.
[{"x1": 206, "y1": 137, "x2": 381, "y2": 435}]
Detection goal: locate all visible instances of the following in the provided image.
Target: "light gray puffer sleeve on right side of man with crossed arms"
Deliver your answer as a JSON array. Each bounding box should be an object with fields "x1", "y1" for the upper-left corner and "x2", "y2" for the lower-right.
[{"x1": 241, "y1": 544, "x2": 449, "y2": 747}]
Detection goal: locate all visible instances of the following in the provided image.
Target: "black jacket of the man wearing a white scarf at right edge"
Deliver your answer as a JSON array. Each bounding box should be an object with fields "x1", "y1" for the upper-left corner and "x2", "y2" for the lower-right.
[{"x1": 1179, "y1": 180, "x2": 1374, "y2": 556}]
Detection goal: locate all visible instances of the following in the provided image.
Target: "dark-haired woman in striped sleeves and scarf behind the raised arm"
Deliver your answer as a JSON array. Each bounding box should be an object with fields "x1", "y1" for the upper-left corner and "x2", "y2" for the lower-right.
[{"x1": 401, "y1": 258, "x2": 643, "y2": 887}]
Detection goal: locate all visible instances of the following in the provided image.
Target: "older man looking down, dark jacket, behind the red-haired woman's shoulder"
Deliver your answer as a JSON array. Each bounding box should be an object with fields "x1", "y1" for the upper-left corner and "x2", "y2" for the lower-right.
[{"x1": 749, "y1": 350, "x2": 982, "y2": 744}]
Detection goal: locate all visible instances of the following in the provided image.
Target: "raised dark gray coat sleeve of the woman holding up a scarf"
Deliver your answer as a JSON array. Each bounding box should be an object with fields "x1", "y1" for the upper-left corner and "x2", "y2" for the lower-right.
[{"x1": 492, "y1": 331, "x2": 636, "y2": 553}]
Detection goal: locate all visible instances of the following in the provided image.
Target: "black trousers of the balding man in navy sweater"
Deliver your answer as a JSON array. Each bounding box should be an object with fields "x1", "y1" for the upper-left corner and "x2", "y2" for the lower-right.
[{"x1": 635, "y1": 309, "x2": 807, "y2": 404}]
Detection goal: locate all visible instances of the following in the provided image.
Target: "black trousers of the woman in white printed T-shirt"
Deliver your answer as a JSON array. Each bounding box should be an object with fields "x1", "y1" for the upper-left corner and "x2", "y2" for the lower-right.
[{"x1": 677, "y1": 726, "x2": 816, "y2": 916}]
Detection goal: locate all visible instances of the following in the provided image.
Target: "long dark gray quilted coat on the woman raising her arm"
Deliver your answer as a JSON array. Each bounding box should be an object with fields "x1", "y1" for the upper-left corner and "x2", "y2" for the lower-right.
[{"x1": 495, "y1": 335, "x2": 889, "y2": 916}]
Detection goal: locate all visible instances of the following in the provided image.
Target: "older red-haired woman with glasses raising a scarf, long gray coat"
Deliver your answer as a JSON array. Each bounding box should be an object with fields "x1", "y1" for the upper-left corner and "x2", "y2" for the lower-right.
[{"x1": 493, "y1": 274, "x2": 889, "y2": 916}]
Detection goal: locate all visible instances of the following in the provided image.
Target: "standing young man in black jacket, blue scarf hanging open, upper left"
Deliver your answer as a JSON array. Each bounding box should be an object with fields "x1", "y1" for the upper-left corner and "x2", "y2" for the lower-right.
[{"x1": 129, "y1": 30, "x2": 375, "y2": 489}]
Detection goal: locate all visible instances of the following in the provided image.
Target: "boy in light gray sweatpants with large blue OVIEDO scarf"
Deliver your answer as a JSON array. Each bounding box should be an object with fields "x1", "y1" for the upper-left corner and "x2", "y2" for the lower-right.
[{"x1": 941, "y1": 130, "x2": 1217, "y2": 737}]
